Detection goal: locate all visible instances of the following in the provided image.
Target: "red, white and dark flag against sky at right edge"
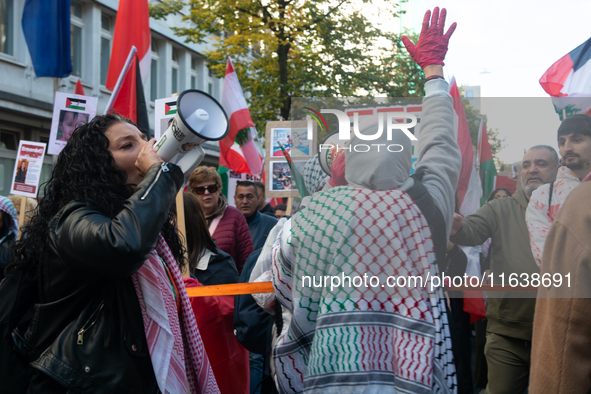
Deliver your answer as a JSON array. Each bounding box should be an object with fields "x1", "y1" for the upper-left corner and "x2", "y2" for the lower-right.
[{"x1": 540, "y1": 38, "x2": 591, "y2": 119}]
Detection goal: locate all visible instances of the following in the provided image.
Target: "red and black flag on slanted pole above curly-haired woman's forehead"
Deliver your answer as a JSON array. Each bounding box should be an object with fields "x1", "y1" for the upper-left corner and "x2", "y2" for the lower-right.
[{"x1": 105, "y1": 47, "x2": 150, "y2": 137}]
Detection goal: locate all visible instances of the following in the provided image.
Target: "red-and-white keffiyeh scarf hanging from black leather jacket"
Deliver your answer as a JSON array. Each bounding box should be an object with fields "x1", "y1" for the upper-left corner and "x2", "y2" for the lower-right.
[{"x1": 132, "y1": 235, "x2": 219, "y2": 393}]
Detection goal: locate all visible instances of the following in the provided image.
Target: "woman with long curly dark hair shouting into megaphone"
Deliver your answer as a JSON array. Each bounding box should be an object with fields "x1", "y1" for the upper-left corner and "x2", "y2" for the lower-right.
[{"x1": 0, "y1": 115, "x2": 218, "y2": 393}]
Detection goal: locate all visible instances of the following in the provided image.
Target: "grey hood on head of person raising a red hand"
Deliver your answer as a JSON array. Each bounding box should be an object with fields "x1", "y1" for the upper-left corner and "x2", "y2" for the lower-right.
[{"x1": 345, "y1": 117, "x2": 412, "y2": 190}]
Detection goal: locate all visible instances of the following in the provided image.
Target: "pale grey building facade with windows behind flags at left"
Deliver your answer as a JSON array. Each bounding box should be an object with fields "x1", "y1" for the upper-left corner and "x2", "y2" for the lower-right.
[{"x1": 0, "y1": 0, "x2": 223, "y2": 195}]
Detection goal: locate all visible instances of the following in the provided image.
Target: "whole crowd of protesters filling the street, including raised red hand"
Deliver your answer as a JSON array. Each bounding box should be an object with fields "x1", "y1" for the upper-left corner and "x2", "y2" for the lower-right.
[{"x1": 0, "y1": 8, "x2": 591, "y2": 394}]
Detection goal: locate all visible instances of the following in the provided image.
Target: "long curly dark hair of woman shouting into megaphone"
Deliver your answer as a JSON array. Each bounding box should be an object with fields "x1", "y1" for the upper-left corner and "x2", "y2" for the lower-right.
[{"x1": 7, "y1": 114, "x2": 186, "y2": 272}]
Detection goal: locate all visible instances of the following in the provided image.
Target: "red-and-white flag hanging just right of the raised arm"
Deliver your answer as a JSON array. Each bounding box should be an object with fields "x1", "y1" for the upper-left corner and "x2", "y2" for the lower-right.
[{"x1": 449, "y1": 78, "x2": 482, "y2": 216}]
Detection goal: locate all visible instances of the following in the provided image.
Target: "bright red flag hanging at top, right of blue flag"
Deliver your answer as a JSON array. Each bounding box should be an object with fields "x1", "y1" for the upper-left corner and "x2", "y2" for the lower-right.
[{"x1": 105, "y1": 0, "x2": 151, "y2": 91}]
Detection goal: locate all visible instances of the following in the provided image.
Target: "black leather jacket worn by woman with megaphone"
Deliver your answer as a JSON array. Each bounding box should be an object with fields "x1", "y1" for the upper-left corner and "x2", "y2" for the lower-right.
[{"x1": 0, "y1": 164, "x2": 183, "y2": 393}]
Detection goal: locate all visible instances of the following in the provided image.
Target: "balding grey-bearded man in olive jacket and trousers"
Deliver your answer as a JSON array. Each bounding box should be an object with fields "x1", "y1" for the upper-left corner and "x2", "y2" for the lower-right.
[{"x1": 450, "y1": 145, "x2": 558, "y2": 394}]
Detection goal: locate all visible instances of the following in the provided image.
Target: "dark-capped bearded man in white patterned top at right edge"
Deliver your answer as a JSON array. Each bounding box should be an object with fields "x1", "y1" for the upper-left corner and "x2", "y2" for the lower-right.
[{"x1": 525, "y1": 115, "x2": 591, "y2": 266}]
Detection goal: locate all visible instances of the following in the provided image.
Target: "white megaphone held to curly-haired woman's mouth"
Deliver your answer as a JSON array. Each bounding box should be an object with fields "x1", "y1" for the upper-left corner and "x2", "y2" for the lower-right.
[{"x1": 154, "y1": 89, "x2": 229, "y2": 175}]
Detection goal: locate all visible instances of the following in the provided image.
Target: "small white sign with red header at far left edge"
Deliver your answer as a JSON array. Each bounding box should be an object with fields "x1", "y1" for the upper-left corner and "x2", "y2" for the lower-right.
[{"x1": 10, "y1": 140, "x2": 46, "y2": 198}]
